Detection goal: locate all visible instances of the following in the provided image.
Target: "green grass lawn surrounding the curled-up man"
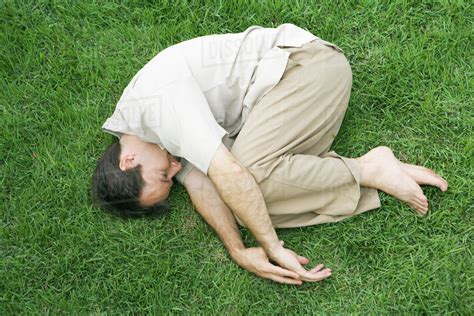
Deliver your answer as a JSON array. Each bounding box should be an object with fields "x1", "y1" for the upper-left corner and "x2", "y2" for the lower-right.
[{"x1": 0, "y1": 0, "x2": 474, "y2": 315}]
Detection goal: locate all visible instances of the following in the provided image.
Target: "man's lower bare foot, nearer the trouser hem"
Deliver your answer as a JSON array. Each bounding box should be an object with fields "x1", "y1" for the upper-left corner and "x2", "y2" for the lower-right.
[{"x1": 357, "y1": 146, "x2": 436, "y2": 214}]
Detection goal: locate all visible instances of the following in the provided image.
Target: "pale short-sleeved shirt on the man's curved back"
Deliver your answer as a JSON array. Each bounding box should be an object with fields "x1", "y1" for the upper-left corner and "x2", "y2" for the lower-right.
[{"x1": 102, "y1": 24, "x2": 318, "y2": 183}]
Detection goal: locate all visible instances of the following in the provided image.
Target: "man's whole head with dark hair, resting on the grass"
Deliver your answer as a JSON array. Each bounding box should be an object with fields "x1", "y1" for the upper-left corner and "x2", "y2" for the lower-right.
[{"x1": 92, "y1": 134, "x2": 181, "y2": 217}]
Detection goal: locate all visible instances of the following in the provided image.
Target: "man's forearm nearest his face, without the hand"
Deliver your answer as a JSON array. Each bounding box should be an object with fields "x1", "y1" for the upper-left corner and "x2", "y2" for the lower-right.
[{"x1": 184, "y1": 169, "x2": 245, "y2": 260}]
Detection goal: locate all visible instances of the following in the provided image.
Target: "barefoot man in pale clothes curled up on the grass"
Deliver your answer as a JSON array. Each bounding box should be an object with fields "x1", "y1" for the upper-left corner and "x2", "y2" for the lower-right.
[{"x1": 93, "y1": 24, "x2": 448, "y2": 284}]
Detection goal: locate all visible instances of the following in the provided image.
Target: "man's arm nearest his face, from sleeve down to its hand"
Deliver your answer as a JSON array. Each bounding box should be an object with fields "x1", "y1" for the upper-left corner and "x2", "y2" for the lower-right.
[{"x1": 184, "y1": 168, "x2": 308, "y2": 284}]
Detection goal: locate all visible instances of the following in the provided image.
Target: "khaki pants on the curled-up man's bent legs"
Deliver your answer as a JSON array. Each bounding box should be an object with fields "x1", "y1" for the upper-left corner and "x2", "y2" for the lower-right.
[{"x1": 231, "y1": 40, "x2": 380, "y2": 227}]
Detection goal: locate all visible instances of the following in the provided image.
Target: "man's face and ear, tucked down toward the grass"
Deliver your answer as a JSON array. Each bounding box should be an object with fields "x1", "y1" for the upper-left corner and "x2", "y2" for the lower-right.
[{"x1": 121, "y1": 139, "x2": 182, "y2": 207}]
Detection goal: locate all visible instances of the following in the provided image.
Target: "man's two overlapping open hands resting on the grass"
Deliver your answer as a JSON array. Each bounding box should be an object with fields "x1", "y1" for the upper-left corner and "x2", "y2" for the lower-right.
[{"x1": 234, "y1": 241, "x2": 331, "y2": 285}]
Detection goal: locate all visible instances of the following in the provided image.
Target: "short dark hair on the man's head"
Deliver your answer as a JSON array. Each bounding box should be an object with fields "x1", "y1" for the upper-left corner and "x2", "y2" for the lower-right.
[{"x1": 92, "y1": 142, "x2": 169, "y2": 218}]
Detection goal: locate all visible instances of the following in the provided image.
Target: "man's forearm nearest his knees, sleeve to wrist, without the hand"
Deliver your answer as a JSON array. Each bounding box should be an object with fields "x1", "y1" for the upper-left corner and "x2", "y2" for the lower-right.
[{"x1": 208, "y1": 147, "x2": 281, "y2": 253}]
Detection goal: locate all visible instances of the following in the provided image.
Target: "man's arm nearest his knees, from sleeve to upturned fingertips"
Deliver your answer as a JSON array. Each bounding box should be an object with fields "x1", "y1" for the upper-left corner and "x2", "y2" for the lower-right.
[{"x1": 208, "y1": 144, "x2": 331, "y2": 281}]
